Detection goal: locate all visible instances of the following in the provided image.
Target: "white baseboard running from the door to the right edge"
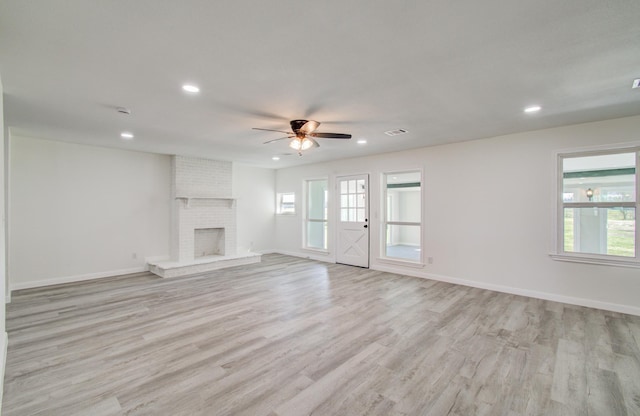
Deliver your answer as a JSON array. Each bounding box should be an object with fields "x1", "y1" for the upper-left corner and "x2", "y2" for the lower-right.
[{"x1": 371, "y1": 264, "x2": 640, "y2": 316}]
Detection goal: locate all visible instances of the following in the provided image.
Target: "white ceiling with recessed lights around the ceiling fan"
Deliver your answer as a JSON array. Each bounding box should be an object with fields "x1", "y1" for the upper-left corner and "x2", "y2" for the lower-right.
[{"x1": 0, "y1": 0, "x2": 640, "y2": 167}]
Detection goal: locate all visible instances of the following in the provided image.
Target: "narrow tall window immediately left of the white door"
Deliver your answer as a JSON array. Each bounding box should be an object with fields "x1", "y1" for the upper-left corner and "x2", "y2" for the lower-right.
[{"x1": 304, "y1": 179, "x2": 329, "y2": 250}]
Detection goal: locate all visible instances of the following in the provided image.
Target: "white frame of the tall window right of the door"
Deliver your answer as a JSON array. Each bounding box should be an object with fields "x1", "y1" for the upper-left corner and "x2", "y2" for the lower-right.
[{"x1": 379, "y1": 168, "x2": 425, "y2": 267}]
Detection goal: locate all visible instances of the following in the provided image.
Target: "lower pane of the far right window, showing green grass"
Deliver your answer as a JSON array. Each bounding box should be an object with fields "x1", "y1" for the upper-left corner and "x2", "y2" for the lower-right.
[{"x1": 564, "y1": 207, "x2": 636, "y2": 257}]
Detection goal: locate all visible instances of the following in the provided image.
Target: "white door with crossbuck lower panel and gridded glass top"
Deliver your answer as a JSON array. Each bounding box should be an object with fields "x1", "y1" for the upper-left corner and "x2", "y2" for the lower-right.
[{"x1": 336, "y1": 174, "x2": 369, "y2": 267}]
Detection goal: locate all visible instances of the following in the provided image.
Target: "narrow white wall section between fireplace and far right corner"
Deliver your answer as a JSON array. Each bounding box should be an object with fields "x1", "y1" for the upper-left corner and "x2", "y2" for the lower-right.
[{"x1": 232, "y1": 163, "x2": 276, "y2": 253}]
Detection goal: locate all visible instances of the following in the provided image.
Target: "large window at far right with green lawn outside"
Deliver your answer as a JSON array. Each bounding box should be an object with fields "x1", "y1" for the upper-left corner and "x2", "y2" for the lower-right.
[{"x1": 557, "y1": 148, "x2": 640, "y2": 266}]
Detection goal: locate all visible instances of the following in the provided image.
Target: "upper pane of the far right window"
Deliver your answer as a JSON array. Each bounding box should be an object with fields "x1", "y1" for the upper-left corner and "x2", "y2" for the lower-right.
[{"x1": 562, "y1": 153, "x2": 636, "y2": 202}]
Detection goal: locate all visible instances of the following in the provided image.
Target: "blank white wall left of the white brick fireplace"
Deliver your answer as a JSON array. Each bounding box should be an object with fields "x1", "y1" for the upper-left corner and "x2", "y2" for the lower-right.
[{"x1": 9, "y1": 135, "x2": 171, "y2": 289}]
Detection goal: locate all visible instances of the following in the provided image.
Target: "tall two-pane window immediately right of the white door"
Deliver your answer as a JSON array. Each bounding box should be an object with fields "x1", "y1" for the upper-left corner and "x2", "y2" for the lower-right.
[{"x1": 383, "y1": 171, "x2": 422, "y2": 262}]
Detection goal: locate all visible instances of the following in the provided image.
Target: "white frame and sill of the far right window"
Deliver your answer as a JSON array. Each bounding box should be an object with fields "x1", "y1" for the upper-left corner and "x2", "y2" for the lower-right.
[{"x1": 550, "y1": 143, "x2": 640, "y2": 268}]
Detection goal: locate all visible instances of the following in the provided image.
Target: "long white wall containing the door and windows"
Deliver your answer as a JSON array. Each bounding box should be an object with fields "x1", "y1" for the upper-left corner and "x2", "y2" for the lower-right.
[{"x1": 276, "y1": 116, "x2": 640, "y2": 315}]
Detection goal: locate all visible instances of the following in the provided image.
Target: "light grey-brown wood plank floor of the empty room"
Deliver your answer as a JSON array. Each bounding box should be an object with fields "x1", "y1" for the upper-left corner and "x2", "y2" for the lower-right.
[{"x1": 3, "y1": 255, "x2": 640, "y2": 416}]
